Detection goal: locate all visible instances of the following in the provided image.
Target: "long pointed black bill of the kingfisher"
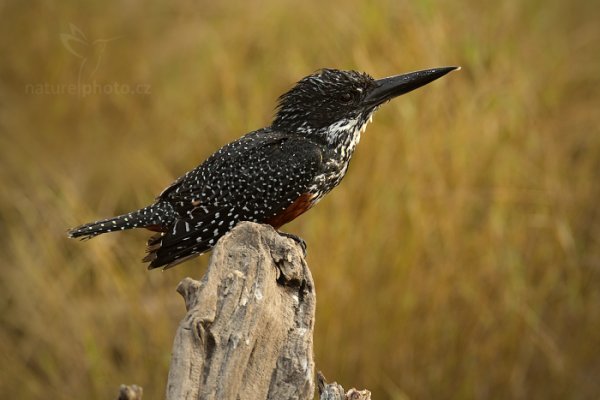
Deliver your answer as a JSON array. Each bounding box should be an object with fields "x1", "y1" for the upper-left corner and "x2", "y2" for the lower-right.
[{"x1": 364, "y1": 67, "x2": 460, "y2": 106}]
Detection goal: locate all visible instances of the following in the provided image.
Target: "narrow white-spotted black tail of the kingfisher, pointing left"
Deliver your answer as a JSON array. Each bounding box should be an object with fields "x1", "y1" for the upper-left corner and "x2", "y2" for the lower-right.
[{"x1": 68, "y1": 202, "x2": 175, "y2": 239}]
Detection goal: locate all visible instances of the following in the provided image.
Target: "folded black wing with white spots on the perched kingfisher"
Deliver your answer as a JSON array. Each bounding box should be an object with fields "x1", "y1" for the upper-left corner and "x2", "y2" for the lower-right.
[{"x1": 145, "y1": 132, "x2": 323, "y2": 268}]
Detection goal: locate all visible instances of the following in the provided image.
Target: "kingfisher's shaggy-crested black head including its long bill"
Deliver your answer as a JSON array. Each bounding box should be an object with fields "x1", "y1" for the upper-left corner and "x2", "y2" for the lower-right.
[{"x1": 273, "y1": 67, "x2": 458, "y2": 148}]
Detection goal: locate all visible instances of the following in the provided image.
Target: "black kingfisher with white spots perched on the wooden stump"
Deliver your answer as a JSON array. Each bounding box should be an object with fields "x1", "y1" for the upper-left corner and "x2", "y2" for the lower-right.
[{"x1": 68, "y1": 66, "x2": 460, "y2": 269}]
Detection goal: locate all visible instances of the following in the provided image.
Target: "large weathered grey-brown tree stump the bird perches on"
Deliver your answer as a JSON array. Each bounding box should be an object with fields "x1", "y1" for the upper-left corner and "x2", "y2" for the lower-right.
[{"x1": 167, "y1": 222, "x2": 316, "y2": 400}]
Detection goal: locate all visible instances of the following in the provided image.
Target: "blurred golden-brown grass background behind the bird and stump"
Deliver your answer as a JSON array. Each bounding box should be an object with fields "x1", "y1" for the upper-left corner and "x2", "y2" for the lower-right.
[{"x1": 0, "y1": 0, "x2": 600, "y2": 399}]
